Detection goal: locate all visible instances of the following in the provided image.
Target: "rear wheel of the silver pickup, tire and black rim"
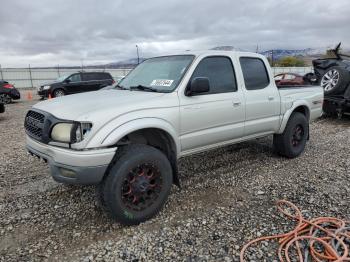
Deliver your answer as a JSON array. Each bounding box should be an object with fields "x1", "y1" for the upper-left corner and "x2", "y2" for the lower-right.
[{"x1": 273, "y1": 112, "x2": 309, "y2": 158}]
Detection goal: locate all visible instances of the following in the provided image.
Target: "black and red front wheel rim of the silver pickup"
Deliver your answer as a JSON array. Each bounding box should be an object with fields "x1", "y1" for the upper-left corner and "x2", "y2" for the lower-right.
[{"x1": 121, "y1": 164, "x2": 162, "y2": 211}]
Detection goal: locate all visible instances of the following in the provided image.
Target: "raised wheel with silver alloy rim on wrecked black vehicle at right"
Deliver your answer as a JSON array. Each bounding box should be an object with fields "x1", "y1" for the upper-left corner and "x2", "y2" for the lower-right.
[{"x1": 321, "y1": 66, "x2": 350, "y2": 95}]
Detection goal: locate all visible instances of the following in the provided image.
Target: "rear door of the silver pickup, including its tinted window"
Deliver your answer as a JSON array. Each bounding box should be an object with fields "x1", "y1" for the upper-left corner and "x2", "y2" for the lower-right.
[{"x1": 239, "y1": 56, "x2": 280, "y2": 136}]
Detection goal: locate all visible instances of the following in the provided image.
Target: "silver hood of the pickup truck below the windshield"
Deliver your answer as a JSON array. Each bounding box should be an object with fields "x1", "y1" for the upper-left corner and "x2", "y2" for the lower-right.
[{"x1": 33, "y1": 90, "x2": 164, "y2": 120}]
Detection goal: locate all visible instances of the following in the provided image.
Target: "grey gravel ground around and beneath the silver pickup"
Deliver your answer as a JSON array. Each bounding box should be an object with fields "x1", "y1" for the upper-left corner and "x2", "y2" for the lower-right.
[{"x1": 0, "y1": 95, "x2": 350, "y2": 261}]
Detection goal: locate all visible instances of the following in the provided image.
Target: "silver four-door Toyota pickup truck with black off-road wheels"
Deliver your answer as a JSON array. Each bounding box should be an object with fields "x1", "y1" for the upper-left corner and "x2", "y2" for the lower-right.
[{"x1": 24, "y1": 51, "x2": 323, "y2": 225}]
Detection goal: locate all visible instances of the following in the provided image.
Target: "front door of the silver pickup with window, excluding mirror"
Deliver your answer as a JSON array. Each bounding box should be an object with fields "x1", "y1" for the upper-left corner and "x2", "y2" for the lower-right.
[{"x1": 180, "y1": 56, "x2": 245, "y2": 152}]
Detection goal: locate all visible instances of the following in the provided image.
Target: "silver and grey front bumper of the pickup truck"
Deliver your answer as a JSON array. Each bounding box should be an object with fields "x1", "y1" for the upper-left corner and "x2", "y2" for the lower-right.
[{"x1": 26, "y1": 136, "x2": 117, "y2": 185}]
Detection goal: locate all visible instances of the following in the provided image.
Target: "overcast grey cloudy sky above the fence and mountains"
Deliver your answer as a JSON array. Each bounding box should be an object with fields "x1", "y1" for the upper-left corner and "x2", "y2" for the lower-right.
[{"x1": 0, "y1": 0, "x2": 350, "y2": 67}]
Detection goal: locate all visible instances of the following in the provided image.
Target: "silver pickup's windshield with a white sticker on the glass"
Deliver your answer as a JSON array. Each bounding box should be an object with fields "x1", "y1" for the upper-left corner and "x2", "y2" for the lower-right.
[{"x1": 119, "y1": 55, "x2": 194, "y2": 93}]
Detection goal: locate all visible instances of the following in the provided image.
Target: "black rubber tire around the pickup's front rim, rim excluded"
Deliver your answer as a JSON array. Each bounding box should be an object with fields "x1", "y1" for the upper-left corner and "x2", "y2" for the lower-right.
[{"x1": 99, "y1": 145, "x2": 173, "y2": 225}]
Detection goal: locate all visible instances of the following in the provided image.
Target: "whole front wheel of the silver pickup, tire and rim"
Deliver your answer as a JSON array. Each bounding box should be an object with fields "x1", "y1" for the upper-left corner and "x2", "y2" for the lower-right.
[{"x1": 102, "y1": 145, "x2": 173, "y2": 225}]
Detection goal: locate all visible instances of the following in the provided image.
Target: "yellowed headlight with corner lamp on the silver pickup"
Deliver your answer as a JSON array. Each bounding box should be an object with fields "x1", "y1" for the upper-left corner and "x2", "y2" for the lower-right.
[{"x1": 51, "y1": 122, "x2": 92, "y2": 144}]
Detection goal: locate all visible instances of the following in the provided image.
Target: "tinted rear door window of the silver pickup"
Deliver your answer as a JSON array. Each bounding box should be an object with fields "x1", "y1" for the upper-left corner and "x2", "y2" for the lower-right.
[{"x1": 239, "y1": 57, "x2": 270, "y2": 90}]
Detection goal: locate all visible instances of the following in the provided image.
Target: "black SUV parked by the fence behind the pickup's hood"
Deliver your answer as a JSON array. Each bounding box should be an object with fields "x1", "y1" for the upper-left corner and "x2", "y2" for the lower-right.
[{"x1": 38, "y1": 72, "x2": 115, "y2": 98}]
